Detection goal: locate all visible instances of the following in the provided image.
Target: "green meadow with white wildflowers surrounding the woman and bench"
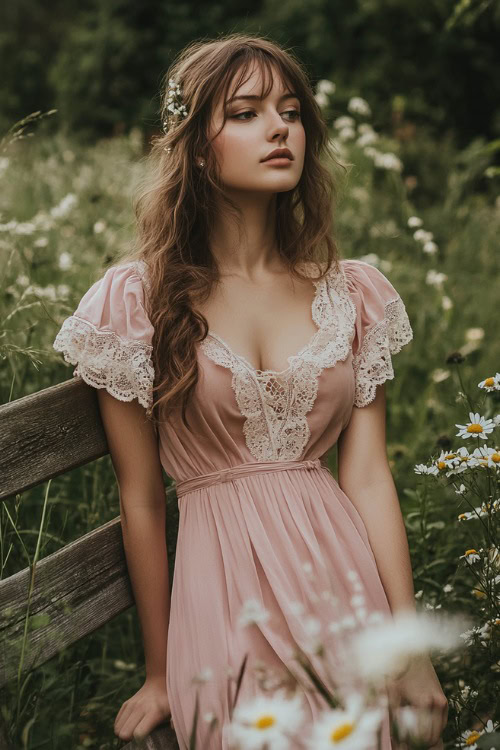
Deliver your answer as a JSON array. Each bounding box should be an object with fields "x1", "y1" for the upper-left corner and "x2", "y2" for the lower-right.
[{"x1": 0, "y1": 91, "x2": 500, "y2": 750}]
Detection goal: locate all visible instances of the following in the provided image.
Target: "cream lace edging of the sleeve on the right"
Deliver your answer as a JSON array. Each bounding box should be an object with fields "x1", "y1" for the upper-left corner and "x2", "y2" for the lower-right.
[{"x1": 353, "y1": 295, "x2": 413, "y2": 407}]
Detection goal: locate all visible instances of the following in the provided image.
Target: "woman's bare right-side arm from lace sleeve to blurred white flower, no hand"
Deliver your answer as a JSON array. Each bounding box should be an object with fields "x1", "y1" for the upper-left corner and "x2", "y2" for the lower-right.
[{"x1": 337, "y1": 384, "x2": 416, "y2": 613}]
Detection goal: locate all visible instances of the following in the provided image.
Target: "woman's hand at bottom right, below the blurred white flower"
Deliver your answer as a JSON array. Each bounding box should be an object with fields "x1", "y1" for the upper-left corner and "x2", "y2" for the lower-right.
[{"x1": 387, "y1": 656, "x2": 448, "y2": 750}]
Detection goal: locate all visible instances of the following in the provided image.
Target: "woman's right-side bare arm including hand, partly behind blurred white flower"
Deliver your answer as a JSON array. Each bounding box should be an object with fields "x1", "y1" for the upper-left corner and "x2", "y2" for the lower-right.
[{"x1": 337, "y1": 384, "x2": 448, "y2": 750}]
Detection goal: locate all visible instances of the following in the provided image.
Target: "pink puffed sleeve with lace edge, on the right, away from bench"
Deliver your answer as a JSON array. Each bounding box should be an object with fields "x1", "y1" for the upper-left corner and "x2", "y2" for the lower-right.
[{"x1": 341, "y1": 260, "x2": 413, "y2": 406}]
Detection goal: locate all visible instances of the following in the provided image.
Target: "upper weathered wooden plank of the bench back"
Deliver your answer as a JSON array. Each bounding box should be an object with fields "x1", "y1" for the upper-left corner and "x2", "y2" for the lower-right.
[{"x1": 0, "y1": 377, "x2": 109, "y2": 500}]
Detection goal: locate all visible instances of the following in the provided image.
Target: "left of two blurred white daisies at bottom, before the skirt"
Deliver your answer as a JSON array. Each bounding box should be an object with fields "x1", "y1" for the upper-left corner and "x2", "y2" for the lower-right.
[{"x1": 223, "y1": 691, "x2": 305, "y2": 750}]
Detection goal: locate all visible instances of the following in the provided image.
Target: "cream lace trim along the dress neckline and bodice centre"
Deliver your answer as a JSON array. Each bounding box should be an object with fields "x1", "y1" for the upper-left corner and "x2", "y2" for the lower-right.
[{"x1": 201, "y1": 264, "x2": 356, "y2": 461}]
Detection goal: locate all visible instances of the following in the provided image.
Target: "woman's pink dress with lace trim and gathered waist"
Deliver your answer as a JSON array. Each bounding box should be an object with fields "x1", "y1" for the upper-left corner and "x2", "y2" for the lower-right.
[{"x1": 53, "y1": 260, "x2": 413, "y2": 750}]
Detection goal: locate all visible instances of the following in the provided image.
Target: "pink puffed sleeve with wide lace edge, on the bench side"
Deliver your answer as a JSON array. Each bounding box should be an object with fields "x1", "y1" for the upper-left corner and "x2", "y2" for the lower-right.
[{"x1": 52, "y1": 261, "x2": 154, "y2": 408}]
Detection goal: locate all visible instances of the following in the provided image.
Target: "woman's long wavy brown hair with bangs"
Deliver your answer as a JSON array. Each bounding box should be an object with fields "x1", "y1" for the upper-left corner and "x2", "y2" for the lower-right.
[{"x1": 118, "y1": 33, "x2": 342, "y2": 429}]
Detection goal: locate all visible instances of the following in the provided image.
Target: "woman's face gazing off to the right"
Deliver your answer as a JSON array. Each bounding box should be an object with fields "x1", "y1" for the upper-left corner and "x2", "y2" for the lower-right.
[{"x1": 210, "y1": 68, "x2": 306, "y2": 193}]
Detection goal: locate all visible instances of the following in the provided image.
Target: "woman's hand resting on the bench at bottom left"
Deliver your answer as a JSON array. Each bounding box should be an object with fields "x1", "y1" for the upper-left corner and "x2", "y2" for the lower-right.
[{"x1": 114, "y1": 676, "x2": 171, "y2": 740}]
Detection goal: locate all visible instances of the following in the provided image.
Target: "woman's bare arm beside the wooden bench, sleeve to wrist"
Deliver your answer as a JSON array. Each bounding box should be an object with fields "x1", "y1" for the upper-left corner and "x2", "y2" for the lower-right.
[{"x1": 97, "y1": 389, "x2": 170, "y2": 683}]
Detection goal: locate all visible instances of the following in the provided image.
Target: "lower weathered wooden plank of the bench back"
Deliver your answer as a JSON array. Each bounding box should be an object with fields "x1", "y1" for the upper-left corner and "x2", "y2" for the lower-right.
[{"x1": 0, "y1": 500, "x2": 177, "y2": 687}]
